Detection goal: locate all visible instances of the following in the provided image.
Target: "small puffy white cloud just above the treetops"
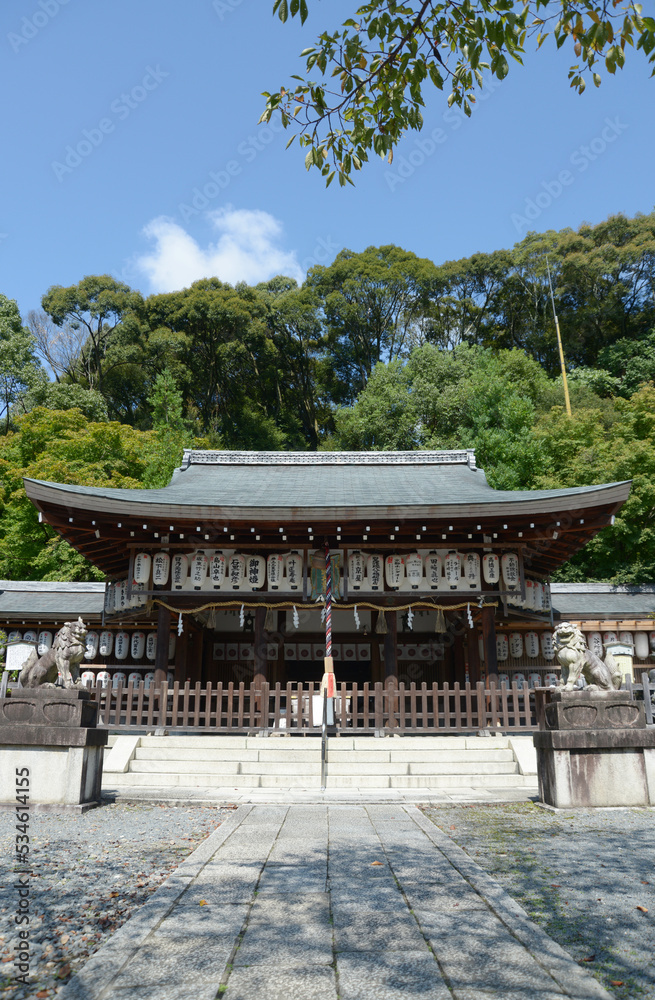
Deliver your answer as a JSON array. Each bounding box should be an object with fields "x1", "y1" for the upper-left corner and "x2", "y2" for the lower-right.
[{"x1": 135, "y1": 205, "x2": 305, "y2": 292}]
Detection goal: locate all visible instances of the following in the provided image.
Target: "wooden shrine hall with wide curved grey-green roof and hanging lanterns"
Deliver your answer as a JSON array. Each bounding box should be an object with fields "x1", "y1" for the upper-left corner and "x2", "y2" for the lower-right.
[{"x1": 18, "y1": 450, "x2": 636, "y2": 712}]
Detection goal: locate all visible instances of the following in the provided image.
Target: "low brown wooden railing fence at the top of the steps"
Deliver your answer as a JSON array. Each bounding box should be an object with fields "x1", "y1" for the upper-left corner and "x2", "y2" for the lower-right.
[{"x1": 93, "y1": 674, "x2": 655, "y2": 735}]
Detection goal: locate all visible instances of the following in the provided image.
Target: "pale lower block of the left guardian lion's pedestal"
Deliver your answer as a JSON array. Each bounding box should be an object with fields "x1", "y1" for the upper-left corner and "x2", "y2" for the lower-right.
[{"x1": 0, "y1": 744, "x2": 104, "y2": 808}]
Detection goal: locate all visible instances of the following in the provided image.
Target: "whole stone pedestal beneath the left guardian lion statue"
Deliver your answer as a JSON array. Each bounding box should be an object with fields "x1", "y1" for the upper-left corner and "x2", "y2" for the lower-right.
[{"x1": 0, "y1": 688, "x2": 108, "y2": 812}]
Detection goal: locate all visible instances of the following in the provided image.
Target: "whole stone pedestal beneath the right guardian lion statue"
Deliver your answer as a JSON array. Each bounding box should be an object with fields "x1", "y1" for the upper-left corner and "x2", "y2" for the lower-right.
[{"x1": 534, "y1": 691, "x2": 655, "y2": 809}]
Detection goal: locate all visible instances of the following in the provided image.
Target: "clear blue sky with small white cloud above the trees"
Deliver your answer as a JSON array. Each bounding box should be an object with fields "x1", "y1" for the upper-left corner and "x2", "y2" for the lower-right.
[{"x1": 0, "y1": 0, "x2": 655, "y2": 314}]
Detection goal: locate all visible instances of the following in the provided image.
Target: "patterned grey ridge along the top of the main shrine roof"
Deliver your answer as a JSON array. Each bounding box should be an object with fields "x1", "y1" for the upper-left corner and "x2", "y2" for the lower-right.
[{"x1": 181, "y1": 448, "x2": 477, "y2": 471}]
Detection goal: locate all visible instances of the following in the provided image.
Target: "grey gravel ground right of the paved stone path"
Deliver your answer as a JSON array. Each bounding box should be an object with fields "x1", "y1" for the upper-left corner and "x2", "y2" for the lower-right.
[{"x1": 424, "y1": 803, "x2": 655, "y2": 1000}]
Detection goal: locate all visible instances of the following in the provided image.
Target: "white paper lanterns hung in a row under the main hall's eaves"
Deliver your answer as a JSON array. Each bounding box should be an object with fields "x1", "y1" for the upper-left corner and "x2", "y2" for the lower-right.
[{"x1": 128, "y1": 550, "x2": 549, "y2": 592}]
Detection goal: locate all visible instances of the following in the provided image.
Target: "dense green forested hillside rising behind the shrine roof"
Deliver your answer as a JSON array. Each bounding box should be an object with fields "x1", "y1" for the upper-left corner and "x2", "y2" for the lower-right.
[{"x1": 0, "y1": 213, "x2": 655, "y2": 582}]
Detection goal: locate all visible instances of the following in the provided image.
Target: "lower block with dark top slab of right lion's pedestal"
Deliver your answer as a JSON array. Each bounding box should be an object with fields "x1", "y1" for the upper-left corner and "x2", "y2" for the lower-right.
[{"x1": 534, "y1": 730, "x2": 655, "y2": 809}]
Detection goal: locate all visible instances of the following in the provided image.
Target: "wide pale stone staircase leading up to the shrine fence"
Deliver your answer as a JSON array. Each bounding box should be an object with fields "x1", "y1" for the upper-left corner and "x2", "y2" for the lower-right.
[{"x1": 103, "y1": 735, "x2": 536, "y2": 792}]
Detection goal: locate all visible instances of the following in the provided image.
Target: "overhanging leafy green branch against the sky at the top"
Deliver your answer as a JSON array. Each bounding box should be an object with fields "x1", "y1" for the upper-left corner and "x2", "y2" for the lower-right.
[{"x1": 262, "y1": 0, "x2": 655, "y2": 184}]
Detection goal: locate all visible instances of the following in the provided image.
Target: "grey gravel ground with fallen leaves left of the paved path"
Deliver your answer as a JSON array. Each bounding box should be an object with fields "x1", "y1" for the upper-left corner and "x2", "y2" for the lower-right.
[{"x1": 0, "y1": 803, "x2": 236, "y2": 1000}]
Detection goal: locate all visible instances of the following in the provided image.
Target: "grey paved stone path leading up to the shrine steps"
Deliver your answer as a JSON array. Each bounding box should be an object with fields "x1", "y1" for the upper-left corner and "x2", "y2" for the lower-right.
[{"x1": 59, "y1": 804, "x2": 609, "y2": 1000}]
